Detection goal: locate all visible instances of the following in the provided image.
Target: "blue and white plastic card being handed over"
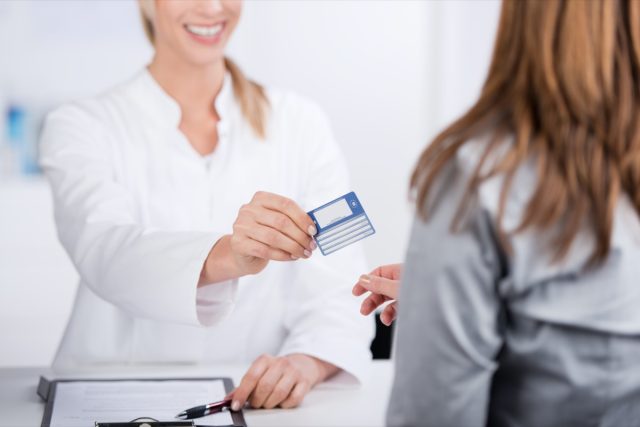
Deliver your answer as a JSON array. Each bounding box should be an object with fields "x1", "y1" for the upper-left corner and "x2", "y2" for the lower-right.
[{"x1": 307, "y1": 191, "x2": 376, "y2": 255}]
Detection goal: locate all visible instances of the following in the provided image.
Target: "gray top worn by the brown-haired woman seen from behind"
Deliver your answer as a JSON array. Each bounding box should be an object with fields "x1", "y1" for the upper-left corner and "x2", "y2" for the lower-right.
[{"x1": 387, "y1": 145, "x2": 640, "y2": 427}]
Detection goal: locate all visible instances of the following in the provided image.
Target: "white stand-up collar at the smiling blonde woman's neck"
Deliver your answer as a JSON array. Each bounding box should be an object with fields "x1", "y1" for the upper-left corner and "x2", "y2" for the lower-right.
[{"x1": 130, "y1": 68, "x2": 234, "y2": 129}]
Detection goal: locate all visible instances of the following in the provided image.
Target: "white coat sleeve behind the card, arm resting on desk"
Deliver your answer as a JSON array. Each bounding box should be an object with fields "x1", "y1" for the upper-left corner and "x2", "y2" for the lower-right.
[{"x1": 280, "y1": 97, "x2": 375, "y2": 384}]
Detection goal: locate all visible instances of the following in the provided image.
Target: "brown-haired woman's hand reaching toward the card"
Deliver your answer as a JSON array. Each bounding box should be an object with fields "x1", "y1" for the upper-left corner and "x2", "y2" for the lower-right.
[{"x1": 352, "y1": 264, "x2": 402, "y2": 326}]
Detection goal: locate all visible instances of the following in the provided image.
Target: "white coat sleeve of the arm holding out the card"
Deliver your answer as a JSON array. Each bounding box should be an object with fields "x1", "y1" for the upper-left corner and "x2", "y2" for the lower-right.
[{"x1": 40, "y1": 105, "x2": 236, "y2": 325}]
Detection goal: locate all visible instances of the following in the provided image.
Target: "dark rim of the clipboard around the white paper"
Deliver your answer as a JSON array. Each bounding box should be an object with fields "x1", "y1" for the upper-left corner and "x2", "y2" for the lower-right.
[{"x1": 37, "y1": 376, "x2": 247, "y2": 427}]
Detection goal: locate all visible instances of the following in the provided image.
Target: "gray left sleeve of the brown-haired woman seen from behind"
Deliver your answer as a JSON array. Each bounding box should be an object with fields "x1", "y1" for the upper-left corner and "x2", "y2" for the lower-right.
[{"x1": 387, "y1": 166, "x2": 504, "y2": 427}]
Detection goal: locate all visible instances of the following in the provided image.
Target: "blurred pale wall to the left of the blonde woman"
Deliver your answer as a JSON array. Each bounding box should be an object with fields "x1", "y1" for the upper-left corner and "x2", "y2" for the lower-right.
[{"x1": 0, "y1": 0, "x2": 151, "y2": 366}]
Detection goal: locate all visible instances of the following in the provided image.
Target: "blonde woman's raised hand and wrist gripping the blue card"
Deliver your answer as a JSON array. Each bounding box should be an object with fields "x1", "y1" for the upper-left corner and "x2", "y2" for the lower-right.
[{"x1": 199, "y1": 191, "x2": 316, "y2": 286}]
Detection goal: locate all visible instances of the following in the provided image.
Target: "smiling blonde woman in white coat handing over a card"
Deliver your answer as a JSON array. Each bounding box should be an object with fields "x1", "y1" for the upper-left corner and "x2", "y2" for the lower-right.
[{"x1": 41, "y1": 0, "x2": 373, "y2": 409}]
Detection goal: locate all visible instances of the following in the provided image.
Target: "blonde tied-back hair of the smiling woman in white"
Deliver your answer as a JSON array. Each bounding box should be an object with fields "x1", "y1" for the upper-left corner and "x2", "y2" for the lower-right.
[{"x1": 138, "y1": 0, "x2": 269, "y2": 139}]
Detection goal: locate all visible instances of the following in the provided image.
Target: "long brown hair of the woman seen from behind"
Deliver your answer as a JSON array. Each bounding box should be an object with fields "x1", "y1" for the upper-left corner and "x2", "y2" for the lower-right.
[{"x1": 411, "y1": 0, "x2": 640, "y2": 265}]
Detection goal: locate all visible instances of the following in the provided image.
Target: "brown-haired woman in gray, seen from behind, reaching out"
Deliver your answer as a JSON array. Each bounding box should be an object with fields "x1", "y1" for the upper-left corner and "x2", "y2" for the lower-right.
[{"x1": 356, "y1": 0, "x2": 640, "y2": 427}]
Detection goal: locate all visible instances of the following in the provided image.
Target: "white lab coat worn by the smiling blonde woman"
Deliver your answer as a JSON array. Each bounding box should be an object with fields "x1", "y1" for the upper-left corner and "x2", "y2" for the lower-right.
[{"x1": 41, "y1": 70, "x2": 373, "y2": 380}]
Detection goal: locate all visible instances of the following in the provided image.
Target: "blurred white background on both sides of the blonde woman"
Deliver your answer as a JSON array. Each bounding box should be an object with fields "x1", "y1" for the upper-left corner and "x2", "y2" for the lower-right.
[{"x1": 0, "y1": 0, "x2": 499, "y2": 366}]
